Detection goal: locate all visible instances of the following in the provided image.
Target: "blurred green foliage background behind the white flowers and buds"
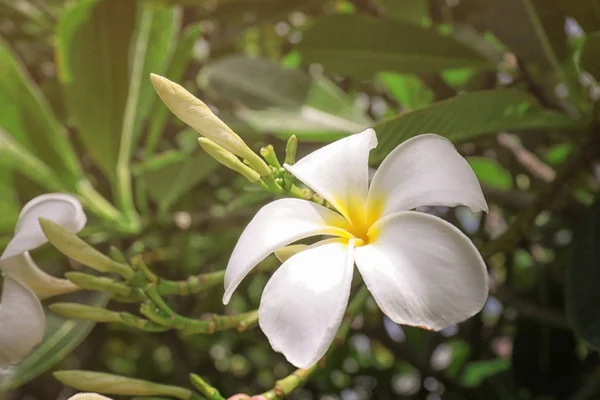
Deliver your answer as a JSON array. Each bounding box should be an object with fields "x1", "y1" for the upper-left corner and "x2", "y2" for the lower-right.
[{"x1": 0, "y1": 0, "x2": 600, "y2": 400}]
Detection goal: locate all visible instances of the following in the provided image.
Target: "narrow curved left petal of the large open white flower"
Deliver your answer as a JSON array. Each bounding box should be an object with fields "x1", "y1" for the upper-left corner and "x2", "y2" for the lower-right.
[{"x1": 223, "y1": 199, "x2": 348, "y2": 304}]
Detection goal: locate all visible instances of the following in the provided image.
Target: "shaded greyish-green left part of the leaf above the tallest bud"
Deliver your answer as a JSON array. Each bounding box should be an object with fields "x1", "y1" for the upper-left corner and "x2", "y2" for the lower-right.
[{"x1": 203, "y1": 55, "x2": 311, "y2": 109}]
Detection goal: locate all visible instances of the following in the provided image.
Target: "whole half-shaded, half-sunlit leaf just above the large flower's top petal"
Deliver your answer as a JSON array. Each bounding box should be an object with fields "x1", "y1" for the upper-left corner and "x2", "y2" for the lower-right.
[{"x1": 200, "y1": 56, "x2": 371, "y2": 140}]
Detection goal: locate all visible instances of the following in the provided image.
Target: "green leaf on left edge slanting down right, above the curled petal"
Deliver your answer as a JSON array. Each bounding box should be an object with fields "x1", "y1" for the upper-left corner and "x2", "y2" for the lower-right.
[{"x1": 0, "y1": 38, "x2": 82, "y2": 182}]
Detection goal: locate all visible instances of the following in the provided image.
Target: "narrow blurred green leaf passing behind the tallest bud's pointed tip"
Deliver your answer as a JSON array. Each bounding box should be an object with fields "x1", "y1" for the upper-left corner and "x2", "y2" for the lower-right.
[{"x1": 145, "y1": 24, "x2": 202, "y2": 157}]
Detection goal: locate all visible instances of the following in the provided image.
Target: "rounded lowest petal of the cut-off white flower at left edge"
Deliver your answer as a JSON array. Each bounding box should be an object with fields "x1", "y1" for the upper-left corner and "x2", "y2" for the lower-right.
[{"x1": 0, "y1": 276, "x2": 45, "y2": 367}]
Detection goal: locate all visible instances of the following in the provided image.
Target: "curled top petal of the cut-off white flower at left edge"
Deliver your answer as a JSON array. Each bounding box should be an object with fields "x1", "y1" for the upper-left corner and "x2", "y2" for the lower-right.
[{"x1": 0, "y1": 193, "x2": 86, "y2": 260}]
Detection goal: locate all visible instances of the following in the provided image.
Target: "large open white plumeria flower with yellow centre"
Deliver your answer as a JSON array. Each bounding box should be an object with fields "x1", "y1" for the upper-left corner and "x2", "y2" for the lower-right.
[{"x1": 223, "y1": 129, "x2": 488, "y2": 368}]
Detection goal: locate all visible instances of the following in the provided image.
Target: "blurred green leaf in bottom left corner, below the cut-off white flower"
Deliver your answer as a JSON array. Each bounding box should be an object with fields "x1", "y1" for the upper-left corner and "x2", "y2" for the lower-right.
[{"x1": 0, "y1": 292, "x2": 109, "y2": 392}]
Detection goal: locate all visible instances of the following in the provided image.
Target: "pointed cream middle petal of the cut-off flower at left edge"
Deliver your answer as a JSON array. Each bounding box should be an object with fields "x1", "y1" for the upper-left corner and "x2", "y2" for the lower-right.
[{"x1": 0, "y1": 252, "x2": 80, "y2": 300}]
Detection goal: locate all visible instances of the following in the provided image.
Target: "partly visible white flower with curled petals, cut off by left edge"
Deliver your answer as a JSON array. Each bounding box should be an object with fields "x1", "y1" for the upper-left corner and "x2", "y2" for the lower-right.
[{"x1": 0, "y1": 193, "x2": 86, "y2": 367}]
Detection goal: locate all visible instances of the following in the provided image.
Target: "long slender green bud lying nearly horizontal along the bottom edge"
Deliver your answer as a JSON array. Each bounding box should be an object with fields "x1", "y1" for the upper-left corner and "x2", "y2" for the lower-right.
[{"x1": 53, "y1": 370, "x2": 192, "y2": 400}]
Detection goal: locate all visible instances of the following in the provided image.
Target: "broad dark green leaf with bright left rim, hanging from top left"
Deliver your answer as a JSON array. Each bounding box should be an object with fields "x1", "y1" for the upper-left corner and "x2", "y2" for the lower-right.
[{"x1": 56, "y1": 0, "x2": 137, "y2": 177}]
